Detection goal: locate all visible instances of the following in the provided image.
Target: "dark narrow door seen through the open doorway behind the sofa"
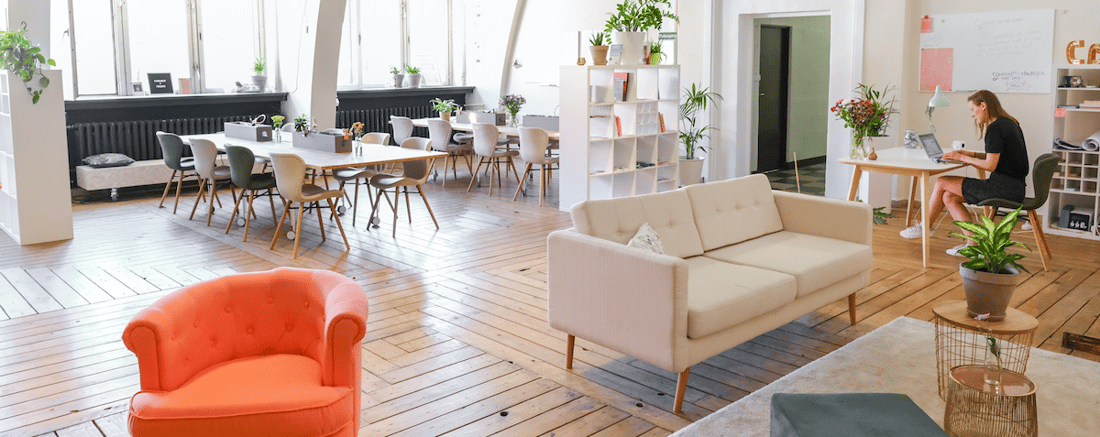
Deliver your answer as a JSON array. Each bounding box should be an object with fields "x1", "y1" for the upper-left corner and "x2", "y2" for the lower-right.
[{"x1": 755, "y1": 25, "x2": 791, "y2": 173}]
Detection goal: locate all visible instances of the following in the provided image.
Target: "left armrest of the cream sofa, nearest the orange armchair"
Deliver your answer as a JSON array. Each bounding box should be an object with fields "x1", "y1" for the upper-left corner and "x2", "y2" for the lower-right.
[{"x1": 547, "y1": 230, "x2": 688, "y2": 370}]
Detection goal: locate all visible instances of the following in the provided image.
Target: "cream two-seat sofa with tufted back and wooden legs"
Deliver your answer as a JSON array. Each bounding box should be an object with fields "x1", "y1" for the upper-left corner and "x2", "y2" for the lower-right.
[{"x1": 548, "y1": 171, "x2": 872, "y2": 413}]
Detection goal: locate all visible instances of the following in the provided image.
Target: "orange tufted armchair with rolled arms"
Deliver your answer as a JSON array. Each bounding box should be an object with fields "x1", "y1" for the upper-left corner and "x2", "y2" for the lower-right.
[{"x1": 122, "y1": 267, "x2": 367, "y2": 437}]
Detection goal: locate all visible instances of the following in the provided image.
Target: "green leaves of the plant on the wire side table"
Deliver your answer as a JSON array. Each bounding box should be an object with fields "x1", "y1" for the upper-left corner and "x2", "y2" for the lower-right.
[{"x1": 952, "y1": 208, "x2": 1031, "y2": 273}]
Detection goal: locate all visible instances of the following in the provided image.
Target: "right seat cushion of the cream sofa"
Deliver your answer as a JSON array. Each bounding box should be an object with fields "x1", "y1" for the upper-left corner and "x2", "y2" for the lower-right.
[{"x1": 693, "y1": 231, "x2": 871, "y2": 297}]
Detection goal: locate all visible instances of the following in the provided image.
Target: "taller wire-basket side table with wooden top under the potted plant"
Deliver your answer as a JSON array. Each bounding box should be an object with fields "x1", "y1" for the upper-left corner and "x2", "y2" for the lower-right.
[{"x1": 932, "y1": 301, "x2": 1038, "y2": 401}]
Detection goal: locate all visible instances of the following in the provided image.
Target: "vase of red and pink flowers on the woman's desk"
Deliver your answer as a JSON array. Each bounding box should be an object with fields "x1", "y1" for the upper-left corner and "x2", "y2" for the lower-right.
[{"x1": 829, "y1": 84, "x2": 898, "y2": 160}]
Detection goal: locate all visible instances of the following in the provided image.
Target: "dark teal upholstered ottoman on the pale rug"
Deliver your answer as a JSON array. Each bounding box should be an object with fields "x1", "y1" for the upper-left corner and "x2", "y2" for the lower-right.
[{"x1": 771, "y1": 393, "x2": 947, "y2": 437}]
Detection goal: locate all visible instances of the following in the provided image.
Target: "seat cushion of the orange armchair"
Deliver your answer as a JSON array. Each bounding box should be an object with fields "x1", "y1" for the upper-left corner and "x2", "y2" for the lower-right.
[{"x1": 130, "y1": 353, "x2": 359, "y2": 436}]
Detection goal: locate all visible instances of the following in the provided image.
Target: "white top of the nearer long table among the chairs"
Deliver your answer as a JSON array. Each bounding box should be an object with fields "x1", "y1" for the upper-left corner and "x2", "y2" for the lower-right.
[{"x1": 180, "y1": 132, "x2": 447, "y2": 171}]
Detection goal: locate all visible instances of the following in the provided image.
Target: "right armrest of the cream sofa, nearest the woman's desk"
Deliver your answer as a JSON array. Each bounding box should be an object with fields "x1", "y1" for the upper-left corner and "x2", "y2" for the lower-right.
[{"x1": 772, "y1": 192, "x2": 873, "y2": 245}]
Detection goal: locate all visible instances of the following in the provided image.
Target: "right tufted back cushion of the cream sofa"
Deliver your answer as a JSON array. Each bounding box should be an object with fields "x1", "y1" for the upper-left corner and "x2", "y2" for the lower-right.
[{"x1": 685, "y1": 174, "x2": 783, "y2": 250}]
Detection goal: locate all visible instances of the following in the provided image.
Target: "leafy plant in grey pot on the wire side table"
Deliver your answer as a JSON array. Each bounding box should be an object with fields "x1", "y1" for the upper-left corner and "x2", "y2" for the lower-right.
[{"x1": 952, "y1": 208, "x2": 1031, "y2": 321}]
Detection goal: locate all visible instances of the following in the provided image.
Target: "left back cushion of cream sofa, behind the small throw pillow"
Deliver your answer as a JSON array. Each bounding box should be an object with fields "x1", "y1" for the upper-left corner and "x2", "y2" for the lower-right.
[{"x1": 570, "y1": 189, "x2": 703, "y2": 258}]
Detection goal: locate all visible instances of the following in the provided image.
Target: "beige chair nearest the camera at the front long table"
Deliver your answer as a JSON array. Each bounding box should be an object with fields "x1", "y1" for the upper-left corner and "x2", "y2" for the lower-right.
[{"x1": 271, "y1": 153, "x2": 351, "y2": 260}]
